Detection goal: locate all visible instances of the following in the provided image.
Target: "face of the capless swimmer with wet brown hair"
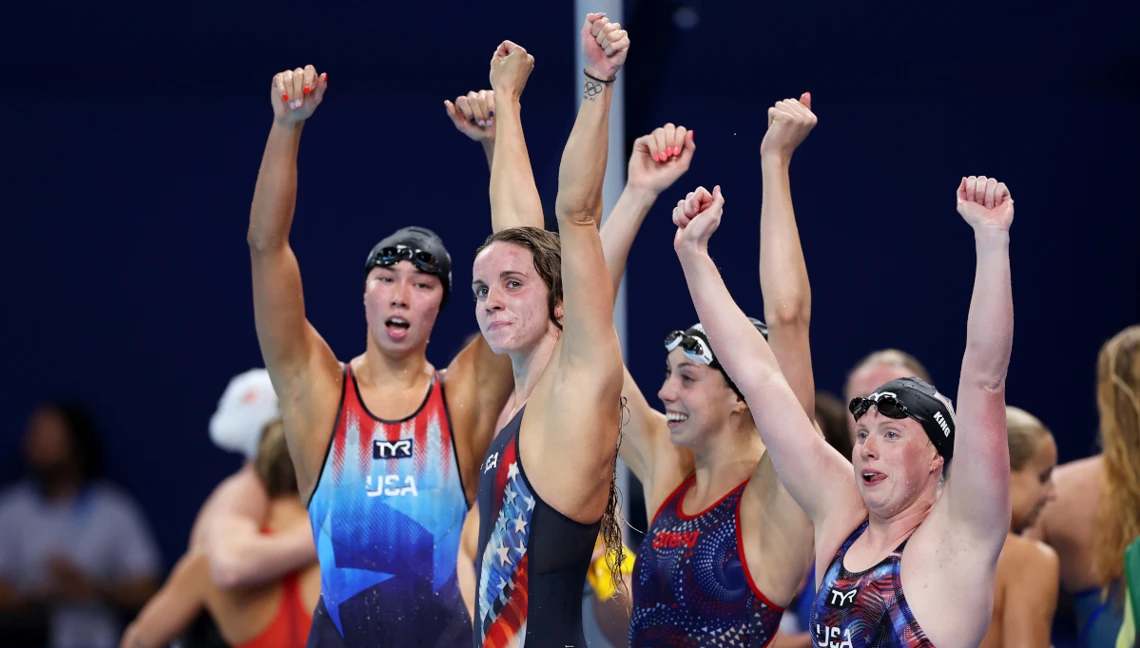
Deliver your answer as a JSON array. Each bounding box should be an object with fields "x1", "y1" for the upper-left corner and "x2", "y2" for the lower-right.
[{"x1": 471, "y1": 241, "x2": 562, "y2": 354}]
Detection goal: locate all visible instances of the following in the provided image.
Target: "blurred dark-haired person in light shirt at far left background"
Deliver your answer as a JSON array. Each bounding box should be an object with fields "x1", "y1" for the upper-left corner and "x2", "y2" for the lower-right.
[{"x1": 0, "y1": 402, "x2": 162, "y2": 648}]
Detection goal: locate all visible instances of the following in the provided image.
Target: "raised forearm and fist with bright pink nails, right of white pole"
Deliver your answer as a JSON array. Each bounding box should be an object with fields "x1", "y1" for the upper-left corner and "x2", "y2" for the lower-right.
[{"x1": 602, "y1": 123, "x2": 697, "y2": 295}]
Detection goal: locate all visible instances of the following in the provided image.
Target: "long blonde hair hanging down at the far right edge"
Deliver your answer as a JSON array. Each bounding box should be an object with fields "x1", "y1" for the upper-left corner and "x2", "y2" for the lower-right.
[{"x1": 1092, "y1": 326, "x2": 1140, "y2": 586}]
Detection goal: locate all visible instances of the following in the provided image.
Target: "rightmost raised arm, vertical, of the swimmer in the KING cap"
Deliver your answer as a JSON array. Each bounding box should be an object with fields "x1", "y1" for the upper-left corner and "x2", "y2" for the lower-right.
[{"x1": 936, "y1": 176, "x2": 1013, "y2": 547}]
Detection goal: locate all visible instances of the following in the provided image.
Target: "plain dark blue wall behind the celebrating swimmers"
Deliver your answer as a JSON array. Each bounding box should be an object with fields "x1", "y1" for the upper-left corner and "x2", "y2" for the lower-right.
[{"x1": 0, "y1": 1, "x2": 1140, "y2": 570}]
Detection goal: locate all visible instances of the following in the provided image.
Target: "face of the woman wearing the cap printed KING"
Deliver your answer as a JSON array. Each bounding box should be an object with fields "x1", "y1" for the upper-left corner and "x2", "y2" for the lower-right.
[{"x1": 852, "y1": 406, "x2": 943, "y2": 517}]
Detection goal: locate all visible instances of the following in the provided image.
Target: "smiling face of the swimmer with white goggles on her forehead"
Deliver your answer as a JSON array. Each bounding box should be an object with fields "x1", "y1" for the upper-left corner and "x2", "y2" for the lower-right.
[{"x1": 657, "y1": 347, "x2": 744, "y2": 449}]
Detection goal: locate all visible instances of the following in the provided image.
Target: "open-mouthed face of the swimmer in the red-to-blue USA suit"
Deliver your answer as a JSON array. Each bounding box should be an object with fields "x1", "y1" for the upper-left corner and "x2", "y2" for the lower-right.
[{"x1": 364, "y1": 261, "x2": 443, "y2": 357}]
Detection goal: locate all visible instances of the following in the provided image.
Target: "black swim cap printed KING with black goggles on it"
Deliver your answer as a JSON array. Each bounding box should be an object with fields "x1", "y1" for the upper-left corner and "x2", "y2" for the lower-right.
[{"x1": 849, "y1": 378, "x2": 955, "y2": 463}]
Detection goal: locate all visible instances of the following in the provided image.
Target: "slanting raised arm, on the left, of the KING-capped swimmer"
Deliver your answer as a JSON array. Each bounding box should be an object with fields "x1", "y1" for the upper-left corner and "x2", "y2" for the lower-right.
[{"x1": 673, "y1": 187, "x2": 860, "y2": 527}]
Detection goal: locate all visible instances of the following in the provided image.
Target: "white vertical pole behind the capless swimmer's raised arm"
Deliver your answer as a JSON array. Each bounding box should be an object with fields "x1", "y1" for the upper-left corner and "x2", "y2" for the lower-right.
[{"x1": 573, "y1": 0, "x2": 629, "y2": 537}]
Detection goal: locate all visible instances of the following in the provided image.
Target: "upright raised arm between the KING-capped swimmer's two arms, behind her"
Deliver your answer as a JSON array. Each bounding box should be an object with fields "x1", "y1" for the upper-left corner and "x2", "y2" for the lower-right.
[{"x1": 760, "y1": 92, "x2": 815, "y2": 420}]
